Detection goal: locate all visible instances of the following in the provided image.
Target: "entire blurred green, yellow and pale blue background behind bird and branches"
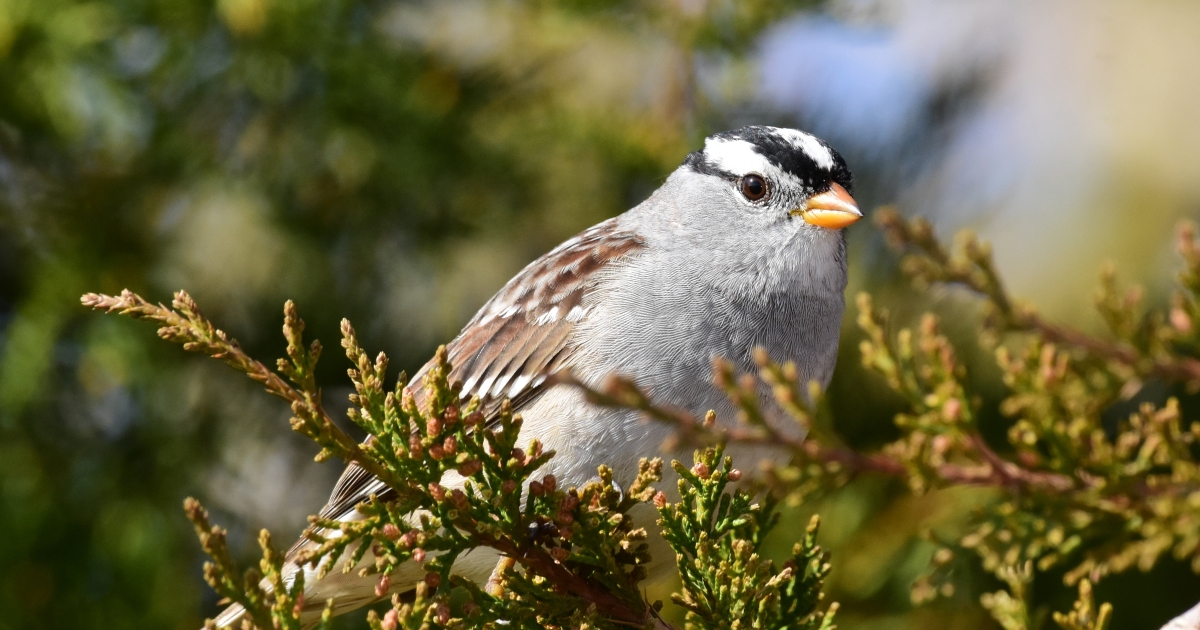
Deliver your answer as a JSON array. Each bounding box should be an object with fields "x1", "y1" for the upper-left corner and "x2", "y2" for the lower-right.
[{"x1": 0, "y1": 0, "x2": 1200, "y2": 629}]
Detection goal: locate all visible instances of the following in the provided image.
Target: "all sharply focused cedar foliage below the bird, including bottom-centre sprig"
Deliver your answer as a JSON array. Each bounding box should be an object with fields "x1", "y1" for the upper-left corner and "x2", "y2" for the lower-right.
[{"x1": 83, "y1": 290, "x2": 835, "y2": 630}]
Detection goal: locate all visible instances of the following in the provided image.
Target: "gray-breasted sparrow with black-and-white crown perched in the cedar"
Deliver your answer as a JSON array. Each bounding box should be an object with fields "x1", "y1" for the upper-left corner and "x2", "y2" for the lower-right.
[{"x1": 216, "y1": 125, "x2": 863, "y2": 628}]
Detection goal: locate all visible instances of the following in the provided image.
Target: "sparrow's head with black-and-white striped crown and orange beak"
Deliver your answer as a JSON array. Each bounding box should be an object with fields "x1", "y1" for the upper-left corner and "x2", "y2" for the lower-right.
[{"x1": 680, "y1": 126, "x2": 863, "y2": 232}]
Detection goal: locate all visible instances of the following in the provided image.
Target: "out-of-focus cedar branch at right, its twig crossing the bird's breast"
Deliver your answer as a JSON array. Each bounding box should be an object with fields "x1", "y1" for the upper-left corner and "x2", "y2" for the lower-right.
[{"x1": 573, "y1": 209, "x2": 1200, "y2": 630}]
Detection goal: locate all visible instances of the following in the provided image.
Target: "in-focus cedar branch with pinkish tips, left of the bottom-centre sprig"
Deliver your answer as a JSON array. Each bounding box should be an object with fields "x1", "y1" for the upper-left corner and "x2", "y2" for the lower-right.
[{"x1": 83, "y1": 292, "x2": 700, "y2": 630}]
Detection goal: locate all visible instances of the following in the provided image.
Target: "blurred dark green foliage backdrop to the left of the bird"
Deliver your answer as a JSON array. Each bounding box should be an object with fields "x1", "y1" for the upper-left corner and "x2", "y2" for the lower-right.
[{"x1": 0, "y1": 0, "x2": 806, "y2": 628}]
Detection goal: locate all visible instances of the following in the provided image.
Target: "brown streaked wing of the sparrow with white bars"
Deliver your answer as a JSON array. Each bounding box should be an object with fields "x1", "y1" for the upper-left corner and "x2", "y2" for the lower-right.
[{"x1": 298, "y1": 220, "x2": 643, "y2": 535}]
